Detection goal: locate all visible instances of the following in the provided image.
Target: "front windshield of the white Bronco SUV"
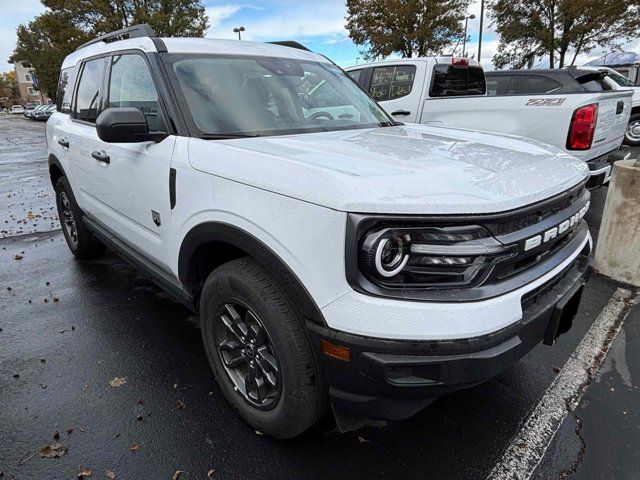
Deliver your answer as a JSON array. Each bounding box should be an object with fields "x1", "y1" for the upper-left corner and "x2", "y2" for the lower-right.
[{"x1": 170, "y1": 55, "x2": 392, "y2": 138}]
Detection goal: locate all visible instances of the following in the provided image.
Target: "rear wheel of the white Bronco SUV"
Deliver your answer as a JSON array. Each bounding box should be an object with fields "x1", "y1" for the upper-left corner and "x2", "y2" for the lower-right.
[{"x1": 55, "y1": 177, "x2": 106, "y2": 260}]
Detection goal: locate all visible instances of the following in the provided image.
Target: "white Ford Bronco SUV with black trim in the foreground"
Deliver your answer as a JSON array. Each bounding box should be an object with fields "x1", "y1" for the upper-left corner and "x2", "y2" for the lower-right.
[{"x1": 47, "y1": 26, "x2": 591, "y2": 438}]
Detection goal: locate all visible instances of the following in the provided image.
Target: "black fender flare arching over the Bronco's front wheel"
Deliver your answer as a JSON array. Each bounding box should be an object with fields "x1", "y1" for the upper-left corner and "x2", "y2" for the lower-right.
[{"x1": 178, "y1": 222, "x2": 326, "y2": 326}]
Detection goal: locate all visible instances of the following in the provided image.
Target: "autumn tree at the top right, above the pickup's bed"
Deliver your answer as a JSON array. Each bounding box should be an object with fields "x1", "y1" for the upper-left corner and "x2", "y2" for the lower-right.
[{"x1": 489, "y1": 0, "x2": 640, "y2": 68}]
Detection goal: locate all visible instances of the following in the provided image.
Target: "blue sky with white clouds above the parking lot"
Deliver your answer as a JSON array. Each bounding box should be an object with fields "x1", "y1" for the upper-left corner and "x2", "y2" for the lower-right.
[{"x1": 0, "y1": 0, "x2": 640, "y2": 71}]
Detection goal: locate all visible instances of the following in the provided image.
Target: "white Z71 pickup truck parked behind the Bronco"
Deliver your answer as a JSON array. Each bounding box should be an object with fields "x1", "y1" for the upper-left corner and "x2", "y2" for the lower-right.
[{"x1": 346, "y1": 56, "x2": 632, "y2": 188}]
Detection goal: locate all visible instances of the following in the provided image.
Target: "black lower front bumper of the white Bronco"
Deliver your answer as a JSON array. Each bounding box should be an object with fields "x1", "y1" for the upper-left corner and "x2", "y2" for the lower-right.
[{"x1": 309, "y1": 254, "x2": 592, "y2": 420}]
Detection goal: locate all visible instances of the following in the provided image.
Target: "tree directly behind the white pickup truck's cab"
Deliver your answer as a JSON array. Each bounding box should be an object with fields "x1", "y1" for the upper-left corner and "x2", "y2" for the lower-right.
[{"x1": 347, "y1": 0, "x2": 470, "y2": 60}]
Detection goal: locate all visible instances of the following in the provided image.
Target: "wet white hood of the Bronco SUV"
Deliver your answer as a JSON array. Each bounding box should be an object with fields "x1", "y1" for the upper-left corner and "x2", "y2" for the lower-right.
[{"x1": 189, "y1": 125, "x2": 589, "y2": 214}]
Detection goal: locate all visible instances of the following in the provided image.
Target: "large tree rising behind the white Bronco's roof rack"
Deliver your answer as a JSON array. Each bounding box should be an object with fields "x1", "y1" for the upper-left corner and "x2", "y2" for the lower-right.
[{"x1": 10, "y1": 0, "x2": 209, "y2": 99}]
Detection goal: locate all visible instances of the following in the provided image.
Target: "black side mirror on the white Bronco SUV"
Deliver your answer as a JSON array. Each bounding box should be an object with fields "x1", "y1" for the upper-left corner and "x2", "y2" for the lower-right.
[{"x1": 96, "y1": 107, "x2": 167, "y2": 143}]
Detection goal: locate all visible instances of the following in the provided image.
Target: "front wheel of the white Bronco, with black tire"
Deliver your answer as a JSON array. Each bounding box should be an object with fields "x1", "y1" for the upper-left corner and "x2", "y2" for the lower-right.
[{"x1": 200, "y1": 257, "x2": 326, "y2": 439}]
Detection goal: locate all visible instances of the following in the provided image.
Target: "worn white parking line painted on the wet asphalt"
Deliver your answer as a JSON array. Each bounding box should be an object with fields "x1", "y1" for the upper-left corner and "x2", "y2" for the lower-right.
[{"x1": 487, "y1": 288, "x2": 633, "y2": 480}]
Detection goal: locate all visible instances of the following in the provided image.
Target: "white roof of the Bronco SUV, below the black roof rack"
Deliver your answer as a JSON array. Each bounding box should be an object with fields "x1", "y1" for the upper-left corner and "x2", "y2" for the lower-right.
[{"x1": 62, "y1": 37, "x2": 330, "y2": 68}]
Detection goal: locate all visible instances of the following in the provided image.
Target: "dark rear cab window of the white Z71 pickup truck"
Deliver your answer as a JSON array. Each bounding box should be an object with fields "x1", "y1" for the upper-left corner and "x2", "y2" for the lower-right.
[{"x1": 430, "y1": 64, "x2": 487, "y2": 97}]
